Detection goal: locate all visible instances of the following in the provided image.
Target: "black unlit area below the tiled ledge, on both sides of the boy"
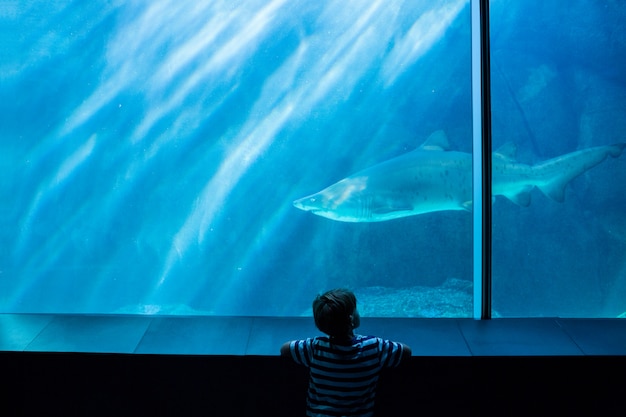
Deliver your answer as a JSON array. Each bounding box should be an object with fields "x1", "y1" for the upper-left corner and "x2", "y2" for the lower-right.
[{"x1": 0, "y1": 352, "x2": 626, "y2": 417}]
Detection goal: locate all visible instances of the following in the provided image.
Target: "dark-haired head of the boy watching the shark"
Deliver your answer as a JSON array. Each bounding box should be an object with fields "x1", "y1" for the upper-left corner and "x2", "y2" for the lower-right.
[{"x1": 313, "y1": 288, "x2": 360, "y2": 337}]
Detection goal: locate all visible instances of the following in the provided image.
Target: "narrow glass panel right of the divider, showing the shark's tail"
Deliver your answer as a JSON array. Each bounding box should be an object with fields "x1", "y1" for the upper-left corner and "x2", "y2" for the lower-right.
[{"x1": 490, "y1": 0, "x2": 626, "y2": 317}]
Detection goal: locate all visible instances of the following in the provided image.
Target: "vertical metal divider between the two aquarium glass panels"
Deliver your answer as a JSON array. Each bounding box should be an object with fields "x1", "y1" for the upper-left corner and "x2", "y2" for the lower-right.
[{"x1": 470, "y1": 0, "x2": 492, "y2": 320}]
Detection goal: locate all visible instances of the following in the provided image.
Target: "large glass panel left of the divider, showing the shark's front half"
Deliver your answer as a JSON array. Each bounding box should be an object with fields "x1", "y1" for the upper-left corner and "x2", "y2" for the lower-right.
[{"x1": 0, "y1": 0, "x2": 472, "y2": 317}]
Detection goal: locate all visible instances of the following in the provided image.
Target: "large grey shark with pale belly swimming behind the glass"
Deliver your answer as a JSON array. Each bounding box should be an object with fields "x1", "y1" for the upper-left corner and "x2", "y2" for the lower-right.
[{"x1": 293, "y1": 130, "x2": 626, "y2": 222}]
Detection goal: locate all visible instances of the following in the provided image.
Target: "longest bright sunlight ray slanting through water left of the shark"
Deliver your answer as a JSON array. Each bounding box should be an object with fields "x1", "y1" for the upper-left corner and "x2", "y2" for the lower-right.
[{"x1": 149, "y1": 1, "x2": 388, "y2": 287}]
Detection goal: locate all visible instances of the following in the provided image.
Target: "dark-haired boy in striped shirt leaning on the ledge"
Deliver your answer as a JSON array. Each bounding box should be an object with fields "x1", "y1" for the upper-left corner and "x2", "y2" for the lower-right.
[{"x1": 280, "y1": 289, "x2": 411, "y2": 417}]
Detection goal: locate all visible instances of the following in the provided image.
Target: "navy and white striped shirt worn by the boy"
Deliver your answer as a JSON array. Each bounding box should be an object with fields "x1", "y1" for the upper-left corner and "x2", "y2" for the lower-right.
[{"x1": 289, "y1": 335, "x2": 402, "y2": 417}]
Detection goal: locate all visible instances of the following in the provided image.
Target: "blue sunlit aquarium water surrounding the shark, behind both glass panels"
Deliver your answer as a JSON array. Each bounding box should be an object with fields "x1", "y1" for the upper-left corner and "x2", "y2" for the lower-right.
[{"x1": 0, "y1": 0, "x2": 626, "y2": 317}]
